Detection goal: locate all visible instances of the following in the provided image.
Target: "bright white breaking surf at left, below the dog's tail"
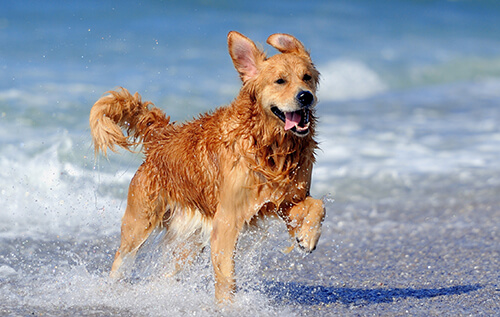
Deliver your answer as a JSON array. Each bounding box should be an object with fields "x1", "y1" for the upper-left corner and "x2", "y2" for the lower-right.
[{"x1": 0, "y1": 135, "x2": 127, "y2": 238}]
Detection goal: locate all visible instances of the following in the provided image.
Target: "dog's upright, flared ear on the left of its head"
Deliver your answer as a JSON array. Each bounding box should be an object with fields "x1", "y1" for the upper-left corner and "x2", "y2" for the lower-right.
[{"x1": 227, "y1": 31, "x2": 265, "y2": 82}]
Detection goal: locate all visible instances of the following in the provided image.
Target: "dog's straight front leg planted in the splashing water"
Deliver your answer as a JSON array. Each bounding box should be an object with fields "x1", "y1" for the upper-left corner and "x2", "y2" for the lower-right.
[{"x1": 210, "y1": 208, "x2": 241, "y2": 303}]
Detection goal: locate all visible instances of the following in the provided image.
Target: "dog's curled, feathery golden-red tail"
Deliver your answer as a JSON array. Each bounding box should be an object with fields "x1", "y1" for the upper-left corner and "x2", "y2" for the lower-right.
[{"x1": 89, "y1": 88, "x2": 170, "y2": 155}]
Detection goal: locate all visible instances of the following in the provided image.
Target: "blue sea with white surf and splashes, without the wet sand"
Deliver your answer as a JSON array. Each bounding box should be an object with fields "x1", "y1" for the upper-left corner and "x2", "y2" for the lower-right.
[{"x1": 0, "y1": 0, "x2": 500, "y2": 315}]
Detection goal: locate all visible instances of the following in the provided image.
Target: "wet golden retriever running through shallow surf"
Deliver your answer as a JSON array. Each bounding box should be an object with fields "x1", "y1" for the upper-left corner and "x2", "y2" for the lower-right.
[{"x1": 89, "y1": 31, "x2": 325, "y2": 302}]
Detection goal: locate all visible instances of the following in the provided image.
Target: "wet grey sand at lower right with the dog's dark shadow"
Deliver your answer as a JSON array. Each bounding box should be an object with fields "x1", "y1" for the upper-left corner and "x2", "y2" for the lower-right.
[{"x1": 267, "y1": 173, "x2": 500, "y2": 316}]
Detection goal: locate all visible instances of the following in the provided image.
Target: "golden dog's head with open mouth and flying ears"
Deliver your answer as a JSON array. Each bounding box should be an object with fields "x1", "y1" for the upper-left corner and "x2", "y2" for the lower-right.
[{"x1": 228, "y1": 31, "x2": 319, "y2": 136}]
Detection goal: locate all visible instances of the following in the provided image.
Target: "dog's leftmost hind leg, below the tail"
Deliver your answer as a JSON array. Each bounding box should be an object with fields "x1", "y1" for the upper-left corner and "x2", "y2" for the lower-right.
[{"x1": 110, "y1": 170, "x2": 164, "y2": 279}]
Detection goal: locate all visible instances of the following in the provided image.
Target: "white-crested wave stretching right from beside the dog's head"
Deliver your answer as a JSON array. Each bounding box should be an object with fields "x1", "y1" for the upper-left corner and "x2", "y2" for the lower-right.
[{"x1": 318, "y1": 56, "x2": 500, "y2": 101}]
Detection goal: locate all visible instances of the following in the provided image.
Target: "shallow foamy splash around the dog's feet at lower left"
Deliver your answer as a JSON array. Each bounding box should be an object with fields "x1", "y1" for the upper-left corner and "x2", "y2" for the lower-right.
[{"x1": 0, "y1": 204, "x2": 312, "y2": 316}]
